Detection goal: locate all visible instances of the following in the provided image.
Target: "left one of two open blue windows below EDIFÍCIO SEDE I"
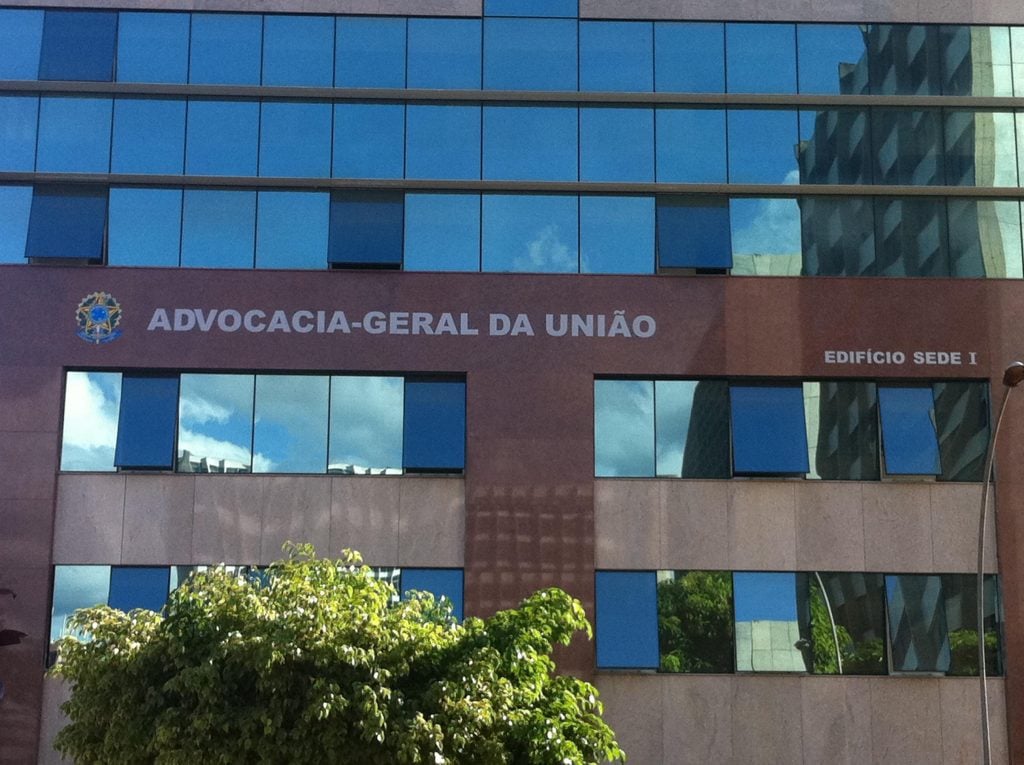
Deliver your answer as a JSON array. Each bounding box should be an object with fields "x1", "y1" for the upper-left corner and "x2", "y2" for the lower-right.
[{"x1": 729, "y1": 385, "x2": 809, "y2": 474}]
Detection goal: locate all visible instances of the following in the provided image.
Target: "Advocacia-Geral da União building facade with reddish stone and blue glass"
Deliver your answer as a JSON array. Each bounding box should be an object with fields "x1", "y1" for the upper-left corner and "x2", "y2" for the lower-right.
[{"x1": 0, "y1": 0, "x2": 1024, "y2": 765}]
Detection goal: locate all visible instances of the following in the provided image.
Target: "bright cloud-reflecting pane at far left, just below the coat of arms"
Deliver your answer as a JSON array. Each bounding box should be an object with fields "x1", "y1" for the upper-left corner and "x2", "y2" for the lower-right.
[{"x1": 60, "y1": 372, "x2": 121, "y2": 473}]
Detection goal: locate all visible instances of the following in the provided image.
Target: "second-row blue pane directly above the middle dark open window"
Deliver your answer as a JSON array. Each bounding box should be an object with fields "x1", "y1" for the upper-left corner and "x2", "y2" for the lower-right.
[{"x1": 332, "y1": 103, "x2": 406, "y2": 178}]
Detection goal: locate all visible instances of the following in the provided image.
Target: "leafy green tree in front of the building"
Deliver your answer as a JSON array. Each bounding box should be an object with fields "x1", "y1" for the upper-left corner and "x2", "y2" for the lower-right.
[{"x1": 53, "y1": 546, "x2": 625, "y2": 765}]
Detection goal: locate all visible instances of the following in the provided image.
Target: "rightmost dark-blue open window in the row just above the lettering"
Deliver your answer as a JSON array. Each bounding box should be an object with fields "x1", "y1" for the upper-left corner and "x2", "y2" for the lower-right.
[{"x1": 657, "y1": 197, "x2": 732, "y2": 268}]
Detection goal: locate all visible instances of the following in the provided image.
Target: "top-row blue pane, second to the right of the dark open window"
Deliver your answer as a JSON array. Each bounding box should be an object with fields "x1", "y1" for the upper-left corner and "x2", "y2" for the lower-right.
[{"x1": 188, "y1": 13, "x2": 263, "y2": 85}]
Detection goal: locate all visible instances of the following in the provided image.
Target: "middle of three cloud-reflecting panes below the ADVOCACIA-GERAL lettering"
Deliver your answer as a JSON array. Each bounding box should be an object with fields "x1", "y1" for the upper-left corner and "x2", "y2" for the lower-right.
[{"x1": 253, "y1": 375, "x2": 330, "y2": 473}]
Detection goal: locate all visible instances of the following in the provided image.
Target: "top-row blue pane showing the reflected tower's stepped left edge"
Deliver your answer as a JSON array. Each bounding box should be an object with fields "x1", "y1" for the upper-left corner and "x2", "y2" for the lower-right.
[{"x1": 797, "y1": 24, "x2": 867, "y2": 95}]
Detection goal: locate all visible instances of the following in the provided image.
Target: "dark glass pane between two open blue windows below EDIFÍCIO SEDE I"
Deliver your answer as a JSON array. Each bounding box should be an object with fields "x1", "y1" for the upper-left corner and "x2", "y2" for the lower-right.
[{"x1": 804, "y1": 380, "x2": 879, "y2": 480}]
